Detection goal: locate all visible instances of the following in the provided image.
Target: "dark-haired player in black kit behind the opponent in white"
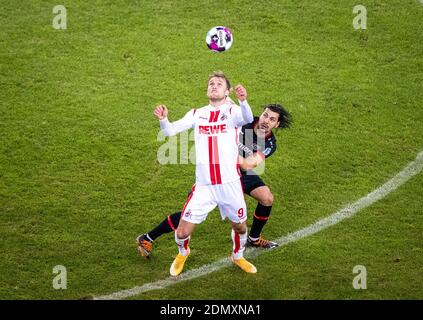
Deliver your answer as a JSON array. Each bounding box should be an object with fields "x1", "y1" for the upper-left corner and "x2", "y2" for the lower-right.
[{"x1": 136, "y1": 104, "x2": 292, "y2": 258}]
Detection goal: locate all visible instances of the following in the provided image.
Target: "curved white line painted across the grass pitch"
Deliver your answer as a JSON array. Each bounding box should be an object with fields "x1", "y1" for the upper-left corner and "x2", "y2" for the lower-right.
[{"x1": 94, "y1": 151, "x2": 423, "y2": 300}]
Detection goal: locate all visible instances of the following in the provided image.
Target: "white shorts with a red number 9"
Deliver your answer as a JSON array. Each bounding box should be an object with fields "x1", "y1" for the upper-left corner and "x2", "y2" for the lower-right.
[{"x1": 181, "y1": 180, "x2": 247, "y2": 224}]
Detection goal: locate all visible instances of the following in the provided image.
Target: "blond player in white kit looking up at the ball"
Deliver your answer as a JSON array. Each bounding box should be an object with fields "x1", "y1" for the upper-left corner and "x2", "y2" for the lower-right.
[{"x1": 154, "y1": 72, "x2": 257, "y2": 276}]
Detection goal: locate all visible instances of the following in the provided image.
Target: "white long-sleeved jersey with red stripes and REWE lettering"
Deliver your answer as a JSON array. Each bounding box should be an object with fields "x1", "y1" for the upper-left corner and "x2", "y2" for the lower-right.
[{"x1": 160, "y1": 101, "x2": 253, "y2": 185}]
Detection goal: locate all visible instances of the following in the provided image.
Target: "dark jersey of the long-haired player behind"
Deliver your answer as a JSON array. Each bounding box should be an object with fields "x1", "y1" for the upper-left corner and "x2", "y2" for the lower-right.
[{"x1": 238, "y1": 117, "x2": 276, "y2": 158}]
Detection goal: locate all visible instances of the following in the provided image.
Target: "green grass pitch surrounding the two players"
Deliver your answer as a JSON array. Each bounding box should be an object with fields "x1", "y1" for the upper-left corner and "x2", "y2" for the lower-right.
[{"x1": 0, "y1": 0, "x2": 423, "y2": 300}]
